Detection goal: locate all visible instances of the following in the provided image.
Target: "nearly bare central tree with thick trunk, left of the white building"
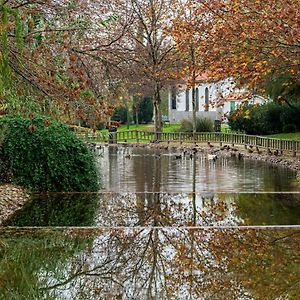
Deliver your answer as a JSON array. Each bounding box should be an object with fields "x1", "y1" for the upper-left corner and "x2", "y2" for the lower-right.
[{"x1": 81, "y1": 0, "x2": 178, "y2": 132}]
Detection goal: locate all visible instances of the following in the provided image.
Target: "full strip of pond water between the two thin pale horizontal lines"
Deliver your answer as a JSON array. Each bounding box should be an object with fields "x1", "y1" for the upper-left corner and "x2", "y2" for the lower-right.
[{"x1": 4, "y1": 193, "x2": 300, "y2": 227}]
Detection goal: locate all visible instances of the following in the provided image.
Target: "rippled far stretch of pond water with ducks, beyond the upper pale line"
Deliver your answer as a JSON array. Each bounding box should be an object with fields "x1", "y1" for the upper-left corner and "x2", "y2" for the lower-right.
[{"x1": 99, "y1": 146, "x2": 299, "y2": 192}]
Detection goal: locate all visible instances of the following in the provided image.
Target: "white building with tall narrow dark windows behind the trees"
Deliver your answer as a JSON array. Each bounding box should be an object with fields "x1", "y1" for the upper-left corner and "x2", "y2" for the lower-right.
[{"x1": 168, "y1": 74, "x2": 265, "y2": 123}]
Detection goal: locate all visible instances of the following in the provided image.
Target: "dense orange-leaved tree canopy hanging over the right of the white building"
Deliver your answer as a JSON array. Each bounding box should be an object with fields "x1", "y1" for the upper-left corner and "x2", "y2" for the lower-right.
[{"x1": 175, "y1": 0, "x2": 300, "y2": 101}]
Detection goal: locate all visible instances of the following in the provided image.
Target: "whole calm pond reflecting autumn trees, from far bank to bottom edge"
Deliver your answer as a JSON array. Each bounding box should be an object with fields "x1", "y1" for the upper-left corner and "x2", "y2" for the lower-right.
[{"x1": 0, "y1": 146, "x2": 300, "y2": 300}]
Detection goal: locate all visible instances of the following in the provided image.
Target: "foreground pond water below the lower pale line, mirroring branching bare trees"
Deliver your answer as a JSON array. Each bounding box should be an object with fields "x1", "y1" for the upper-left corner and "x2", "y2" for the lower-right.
[{"x1": 0, "y1": 228, "x2": 300, "y2": 299}]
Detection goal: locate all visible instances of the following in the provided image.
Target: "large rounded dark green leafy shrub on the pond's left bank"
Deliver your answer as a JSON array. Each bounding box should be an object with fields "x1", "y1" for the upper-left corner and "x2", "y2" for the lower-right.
[{"x1": 0, "y1": 116, "x2": 99, "y2": 192}]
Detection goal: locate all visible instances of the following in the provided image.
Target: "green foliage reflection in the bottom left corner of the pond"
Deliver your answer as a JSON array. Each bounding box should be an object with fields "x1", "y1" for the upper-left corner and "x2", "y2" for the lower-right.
[{"x1": 0, "y1": 229, "x2": 90, "y2": 300}]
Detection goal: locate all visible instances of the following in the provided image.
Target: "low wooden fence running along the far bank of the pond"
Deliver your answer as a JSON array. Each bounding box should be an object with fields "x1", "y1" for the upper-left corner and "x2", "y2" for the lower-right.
[{"x1": 78, "y1": 130, "x2": 300, "y2": 155}]
